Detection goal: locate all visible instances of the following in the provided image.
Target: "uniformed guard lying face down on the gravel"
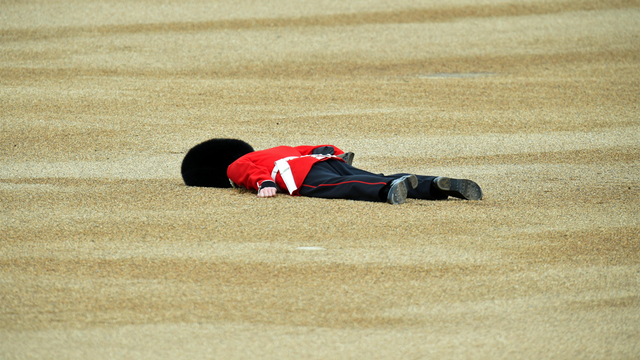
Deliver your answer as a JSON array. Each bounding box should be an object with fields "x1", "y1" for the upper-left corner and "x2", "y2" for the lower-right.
[{"x1": 181, "y1": 139, "x2": 482, "y2": 204}]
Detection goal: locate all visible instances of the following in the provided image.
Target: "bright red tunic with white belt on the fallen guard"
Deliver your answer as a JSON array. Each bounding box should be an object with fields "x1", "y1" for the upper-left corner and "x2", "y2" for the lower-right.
[{"x1": 227, "y1": 145, "x2": 344, "y2": 195}]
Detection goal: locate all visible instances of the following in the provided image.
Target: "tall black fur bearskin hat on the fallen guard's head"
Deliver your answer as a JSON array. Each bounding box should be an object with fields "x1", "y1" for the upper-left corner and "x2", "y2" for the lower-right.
[{"x1": 181, "y1": 139, "x2": 253, "y2": 188}]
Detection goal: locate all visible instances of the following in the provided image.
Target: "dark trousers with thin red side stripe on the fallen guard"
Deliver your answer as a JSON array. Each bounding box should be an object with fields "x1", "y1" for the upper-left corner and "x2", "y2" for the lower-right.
[{"x1": 299, "y1": 160, "x2": 447, "y2": 201}]
